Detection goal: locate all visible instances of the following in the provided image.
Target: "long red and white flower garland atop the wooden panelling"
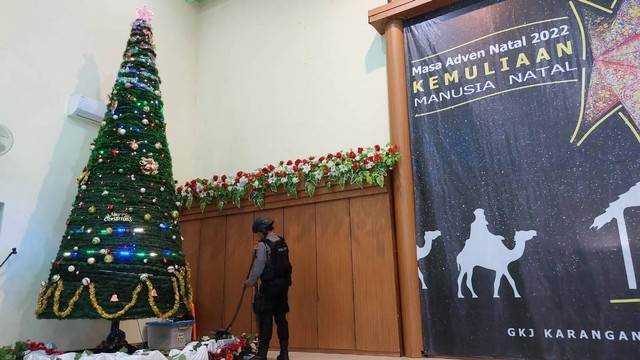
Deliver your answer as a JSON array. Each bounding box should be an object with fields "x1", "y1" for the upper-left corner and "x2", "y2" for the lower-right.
[{"x1": 176, "y1": 144, "x2": 400, "y2": 210}]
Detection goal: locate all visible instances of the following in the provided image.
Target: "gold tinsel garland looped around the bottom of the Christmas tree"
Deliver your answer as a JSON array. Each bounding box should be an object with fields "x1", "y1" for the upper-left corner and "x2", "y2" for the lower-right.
[{"x1": 36, "y1": 265, "x2": 193, "y2": 319}]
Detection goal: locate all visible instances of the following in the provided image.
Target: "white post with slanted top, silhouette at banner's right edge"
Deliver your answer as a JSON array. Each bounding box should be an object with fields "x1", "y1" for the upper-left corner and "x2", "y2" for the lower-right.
[{"x1": 591, "y1": 182, "x2": 640, "y2": 289}]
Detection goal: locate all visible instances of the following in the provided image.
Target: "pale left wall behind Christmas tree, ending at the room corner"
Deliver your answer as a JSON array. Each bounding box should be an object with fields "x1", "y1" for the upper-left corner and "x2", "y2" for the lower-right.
[{"x1": 0, "y1": 0, "x2": 198, "y2": 350}]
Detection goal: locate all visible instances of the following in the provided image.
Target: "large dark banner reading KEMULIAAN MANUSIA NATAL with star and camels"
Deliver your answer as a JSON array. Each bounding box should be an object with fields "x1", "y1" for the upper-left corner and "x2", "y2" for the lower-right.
[{"x1": 405, "y1": 0, "x2": 640, "y2": 359}]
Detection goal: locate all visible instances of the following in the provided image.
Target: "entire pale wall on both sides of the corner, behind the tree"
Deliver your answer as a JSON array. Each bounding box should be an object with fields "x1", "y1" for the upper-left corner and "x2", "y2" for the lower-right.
[{"x1": 0, "y1": 0, "x2": 389, "y2": 350}]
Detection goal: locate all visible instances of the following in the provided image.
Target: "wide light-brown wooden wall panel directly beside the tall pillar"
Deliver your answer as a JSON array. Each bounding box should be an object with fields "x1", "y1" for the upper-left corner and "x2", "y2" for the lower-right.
[{"x1": 350, "y1": 195, "x2": 400, "y2": 352}]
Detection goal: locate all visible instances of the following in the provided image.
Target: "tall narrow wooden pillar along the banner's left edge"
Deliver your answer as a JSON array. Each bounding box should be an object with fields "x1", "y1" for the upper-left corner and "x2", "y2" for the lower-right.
[{"x1": 385, "y1": 19, "x2": 423, "y2": 357}]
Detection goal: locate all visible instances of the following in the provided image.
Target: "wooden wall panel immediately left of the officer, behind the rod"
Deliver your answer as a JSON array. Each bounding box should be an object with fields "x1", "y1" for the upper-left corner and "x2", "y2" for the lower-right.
[{"x1": 222, "y1": 213, "x2": 253, "y2": 333}]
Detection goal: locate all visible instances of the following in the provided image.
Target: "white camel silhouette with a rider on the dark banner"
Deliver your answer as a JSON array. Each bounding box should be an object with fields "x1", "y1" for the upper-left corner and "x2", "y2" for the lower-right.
[{"x1": 456, "y1": 231, "x2": 538, "y2": 298}]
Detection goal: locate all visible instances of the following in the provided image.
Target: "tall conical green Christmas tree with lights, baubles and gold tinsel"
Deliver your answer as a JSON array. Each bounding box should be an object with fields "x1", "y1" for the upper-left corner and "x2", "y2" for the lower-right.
[{"x1": 36, "y1": 8, "x2": 192, "y2": 320}]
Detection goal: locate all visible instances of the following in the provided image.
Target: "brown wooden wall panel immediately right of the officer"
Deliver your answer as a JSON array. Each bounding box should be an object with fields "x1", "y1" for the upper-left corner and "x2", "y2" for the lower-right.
[{"x1": 283, "y1": 204, "x2": 318, "y2": 349}]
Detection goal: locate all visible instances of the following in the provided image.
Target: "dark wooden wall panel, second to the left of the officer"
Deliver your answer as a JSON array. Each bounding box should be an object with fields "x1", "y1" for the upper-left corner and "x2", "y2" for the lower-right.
[{"x1": 196, "y1": 217, "x2": 226, "y2": 336}]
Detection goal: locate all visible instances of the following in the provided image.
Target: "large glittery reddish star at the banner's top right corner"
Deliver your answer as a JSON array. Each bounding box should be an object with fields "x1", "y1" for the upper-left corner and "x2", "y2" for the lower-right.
[{"x1": 571, "y1": 0, "x2": 640, "y2": 146}]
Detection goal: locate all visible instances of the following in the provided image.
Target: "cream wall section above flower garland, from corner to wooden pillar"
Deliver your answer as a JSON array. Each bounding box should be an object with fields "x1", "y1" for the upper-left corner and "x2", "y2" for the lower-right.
[{"x1": 194, "y1": 0, "x2": 389, "y2": 177}]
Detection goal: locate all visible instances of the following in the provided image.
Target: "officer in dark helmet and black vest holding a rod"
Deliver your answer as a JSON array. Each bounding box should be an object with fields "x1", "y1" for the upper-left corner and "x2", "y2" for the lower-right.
[{"x1": 244, "y1": 216, "x2": 291, "y2": 360}]
